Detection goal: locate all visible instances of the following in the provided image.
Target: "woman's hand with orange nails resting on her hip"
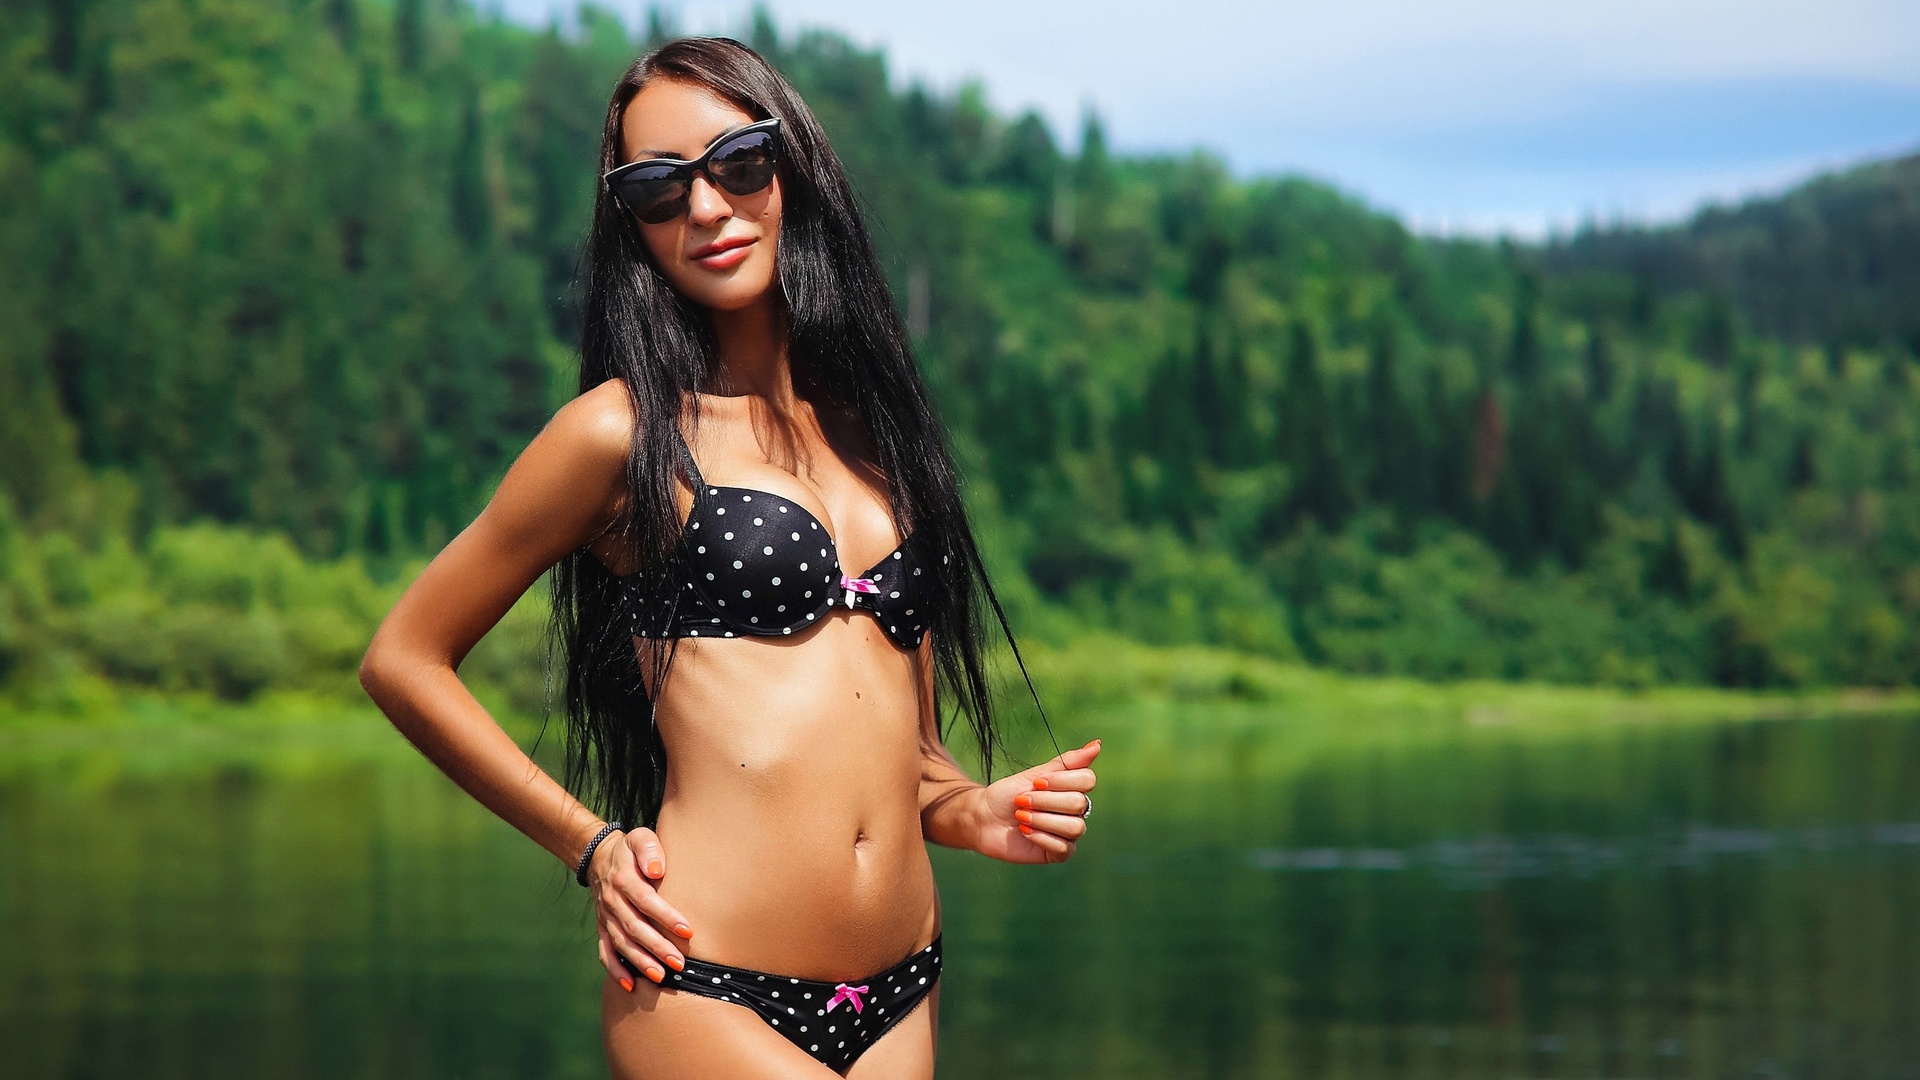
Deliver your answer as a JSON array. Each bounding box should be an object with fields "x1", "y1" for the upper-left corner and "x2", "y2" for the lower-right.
[{"x1": 588, "y1": 828, "x2": 693, "y2": 992}]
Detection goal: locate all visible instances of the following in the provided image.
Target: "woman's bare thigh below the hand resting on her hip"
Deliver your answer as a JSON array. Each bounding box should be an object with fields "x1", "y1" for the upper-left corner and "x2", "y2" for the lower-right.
[{"x1": 601, "y1": 978, "x2": 840, "y2": 1080}]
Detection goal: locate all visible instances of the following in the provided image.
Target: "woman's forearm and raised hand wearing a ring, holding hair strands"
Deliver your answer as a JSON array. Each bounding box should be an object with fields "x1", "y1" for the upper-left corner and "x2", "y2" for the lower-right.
[{"x1": 920, "y1": 634, "x2": 1100, "y2": 863}]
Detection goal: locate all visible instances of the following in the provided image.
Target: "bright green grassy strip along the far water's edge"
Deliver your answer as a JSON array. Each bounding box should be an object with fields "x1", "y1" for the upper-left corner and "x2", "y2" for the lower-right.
[{"x1": 0, "y1": 638, "x2": 1920, "y2": 773}]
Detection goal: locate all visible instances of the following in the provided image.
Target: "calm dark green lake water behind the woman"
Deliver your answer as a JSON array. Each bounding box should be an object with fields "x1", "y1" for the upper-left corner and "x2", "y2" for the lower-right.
[{"x1": 0, "y1": 715, "x2": 1920, "y2": 1080}]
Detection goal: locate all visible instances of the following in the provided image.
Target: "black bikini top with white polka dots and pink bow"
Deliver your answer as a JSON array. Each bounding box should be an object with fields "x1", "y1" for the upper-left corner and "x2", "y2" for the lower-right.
[{"x1": 622, "y1": 430, "x2": 935, "y2": 650}]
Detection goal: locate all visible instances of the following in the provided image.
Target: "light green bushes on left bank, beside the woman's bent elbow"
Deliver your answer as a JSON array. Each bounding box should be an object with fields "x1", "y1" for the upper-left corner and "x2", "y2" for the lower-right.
[{"x1": 0, "y1": 507, "x2": 545, "y2": 713}]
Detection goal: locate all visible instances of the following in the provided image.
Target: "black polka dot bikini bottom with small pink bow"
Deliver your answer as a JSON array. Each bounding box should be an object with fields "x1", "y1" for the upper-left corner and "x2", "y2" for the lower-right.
[{"x1": 666, "y1": 938, "x2": 941, "y2": 1072}]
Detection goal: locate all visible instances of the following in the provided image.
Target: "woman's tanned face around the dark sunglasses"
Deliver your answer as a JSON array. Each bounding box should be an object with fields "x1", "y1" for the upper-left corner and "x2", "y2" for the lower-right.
[{"x1": 620, "y1": 79, "x2": 781, "y2": 311}]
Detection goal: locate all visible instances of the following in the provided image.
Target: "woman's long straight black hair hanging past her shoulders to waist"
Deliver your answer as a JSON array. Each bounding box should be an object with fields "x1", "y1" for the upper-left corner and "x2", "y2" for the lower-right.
[{"x1": 553, "y1": 38, "x2": 1031, "y2": 824}]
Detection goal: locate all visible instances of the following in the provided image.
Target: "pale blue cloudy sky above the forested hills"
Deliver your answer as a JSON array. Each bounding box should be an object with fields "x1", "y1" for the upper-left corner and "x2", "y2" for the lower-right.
[{"x1": 492, "y1": 0, "x2": 1920, "y2": 238}]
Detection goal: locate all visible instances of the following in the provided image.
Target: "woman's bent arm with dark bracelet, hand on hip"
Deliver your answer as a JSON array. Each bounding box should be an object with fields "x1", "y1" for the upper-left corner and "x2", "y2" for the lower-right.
[{"x1": 361, "y1": 382, "x2": 693, "y2": 990}]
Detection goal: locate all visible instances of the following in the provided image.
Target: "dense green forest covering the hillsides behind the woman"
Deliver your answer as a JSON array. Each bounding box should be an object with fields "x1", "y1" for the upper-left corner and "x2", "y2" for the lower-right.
[{"x1": 0, "y1": 0, "x2": 1920, "y2": 707}]
